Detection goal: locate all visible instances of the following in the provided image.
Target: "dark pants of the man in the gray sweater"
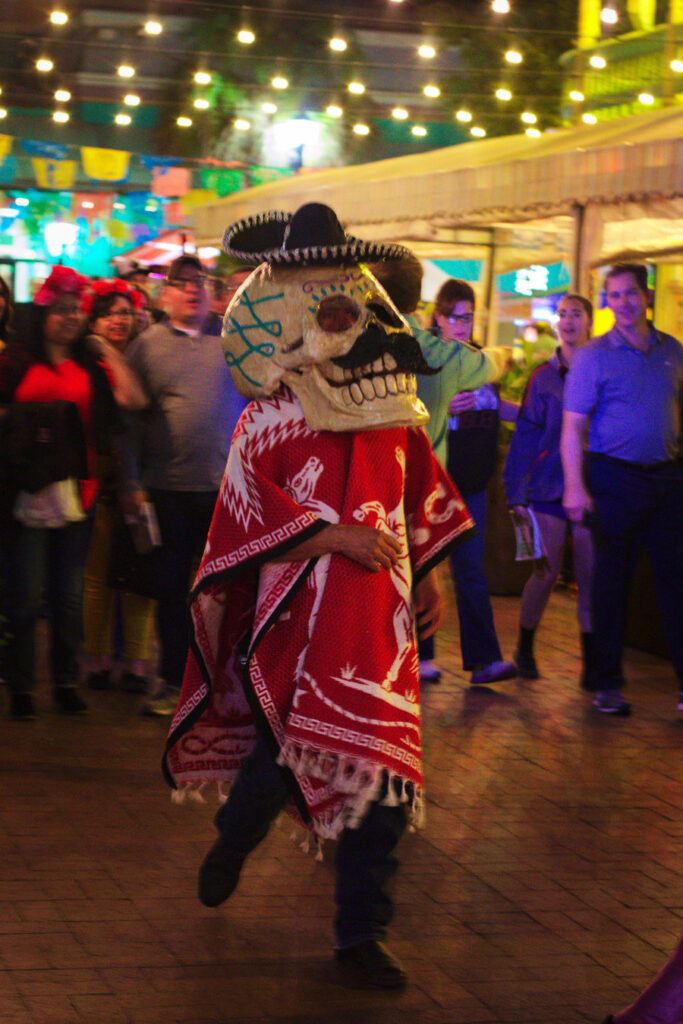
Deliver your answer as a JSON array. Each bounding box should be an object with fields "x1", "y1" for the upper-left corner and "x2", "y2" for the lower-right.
[{"x1": 150, "y1": 490, "x2": 218, "y2": 693}]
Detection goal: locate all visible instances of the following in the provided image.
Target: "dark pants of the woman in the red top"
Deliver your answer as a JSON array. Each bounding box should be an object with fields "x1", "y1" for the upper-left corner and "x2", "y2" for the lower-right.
[{"x1": 5, "y1": 517, "x2": 92, "y2": 693}]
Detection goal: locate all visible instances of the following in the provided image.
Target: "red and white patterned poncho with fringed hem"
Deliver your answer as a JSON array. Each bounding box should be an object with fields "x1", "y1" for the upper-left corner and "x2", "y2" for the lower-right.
[{"x1": 166, "y1": 389, "x2": 472, "y2": 838}]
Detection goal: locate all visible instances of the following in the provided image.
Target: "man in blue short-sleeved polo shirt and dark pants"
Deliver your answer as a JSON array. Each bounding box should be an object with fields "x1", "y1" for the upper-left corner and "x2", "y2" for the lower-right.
[{"x1": 561, "y1": 263, "x2": 683, "y2": 715}]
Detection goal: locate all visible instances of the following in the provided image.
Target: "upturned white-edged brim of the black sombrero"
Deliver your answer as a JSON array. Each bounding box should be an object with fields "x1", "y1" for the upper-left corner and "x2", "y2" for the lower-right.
[{"x1": 223, "y1": 210, "x2": 410, "y2": 266}]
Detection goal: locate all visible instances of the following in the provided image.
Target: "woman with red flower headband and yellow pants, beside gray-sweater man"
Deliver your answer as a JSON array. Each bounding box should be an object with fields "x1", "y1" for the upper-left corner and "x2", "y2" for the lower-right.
[{"x1": 82, "y1": 279, "x2": 154, "y2": 693}]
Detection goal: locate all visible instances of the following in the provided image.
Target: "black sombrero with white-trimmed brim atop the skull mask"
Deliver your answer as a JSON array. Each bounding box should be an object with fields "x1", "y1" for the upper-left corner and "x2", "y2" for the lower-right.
[{"x1": 223, "y1": 203, "x2": 410, "y2": 266}]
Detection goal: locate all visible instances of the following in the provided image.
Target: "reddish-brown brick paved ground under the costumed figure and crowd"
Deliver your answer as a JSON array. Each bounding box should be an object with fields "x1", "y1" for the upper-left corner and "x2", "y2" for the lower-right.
[{"x1": 0, "y1": 593, "x2": 683, "y2": 1024}]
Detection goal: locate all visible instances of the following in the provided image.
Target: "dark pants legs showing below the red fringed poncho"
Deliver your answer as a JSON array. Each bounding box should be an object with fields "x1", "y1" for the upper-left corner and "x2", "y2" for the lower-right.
[{"x1": 216, "y1": 740, "x2": 407, "y2": 947}]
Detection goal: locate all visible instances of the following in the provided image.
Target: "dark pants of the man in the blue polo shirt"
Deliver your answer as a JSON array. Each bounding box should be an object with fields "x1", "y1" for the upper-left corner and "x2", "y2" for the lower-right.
[{"x1": 587, "y1": 456, "x2": 683, "y2": 690}]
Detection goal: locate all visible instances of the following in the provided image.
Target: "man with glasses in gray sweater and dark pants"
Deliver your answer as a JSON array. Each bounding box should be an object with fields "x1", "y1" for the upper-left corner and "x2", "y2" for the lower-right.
[{"x1": 126, "y1": 254, "x2": 245, "y2": 716}]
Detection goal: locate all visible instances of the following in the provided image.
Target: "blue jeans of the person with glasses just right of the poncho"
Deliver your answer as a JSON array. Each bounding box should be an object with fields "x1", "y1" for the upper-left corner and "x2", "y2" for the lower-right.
[{"x1": 449, "y1": 490, "x2": 503, "y2": 672}]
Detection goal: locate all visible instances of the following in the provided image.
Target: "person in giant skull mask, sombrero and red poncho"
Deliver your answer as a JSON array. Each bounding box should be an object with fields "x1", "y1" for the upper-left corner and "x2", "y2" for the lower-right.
[{"x1": 165, "y1": 204, "x2": 472, "y2": 988}]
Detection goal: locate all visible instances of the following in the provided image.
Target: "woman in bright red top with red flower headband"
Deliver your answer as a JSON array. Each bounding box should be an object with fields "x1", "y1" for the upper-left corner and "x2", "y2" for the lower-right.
[{"x1": 0, "y1": 266, "x2": 125, "y2": 719}]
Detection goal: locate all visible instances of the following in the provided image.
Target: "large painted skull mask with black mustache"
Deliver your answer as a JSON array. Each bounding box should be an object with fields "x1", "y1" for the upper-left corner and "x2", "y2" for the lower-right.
[{"x1": 222, "y1": 263, "x2": 430, "y2": 431}]
